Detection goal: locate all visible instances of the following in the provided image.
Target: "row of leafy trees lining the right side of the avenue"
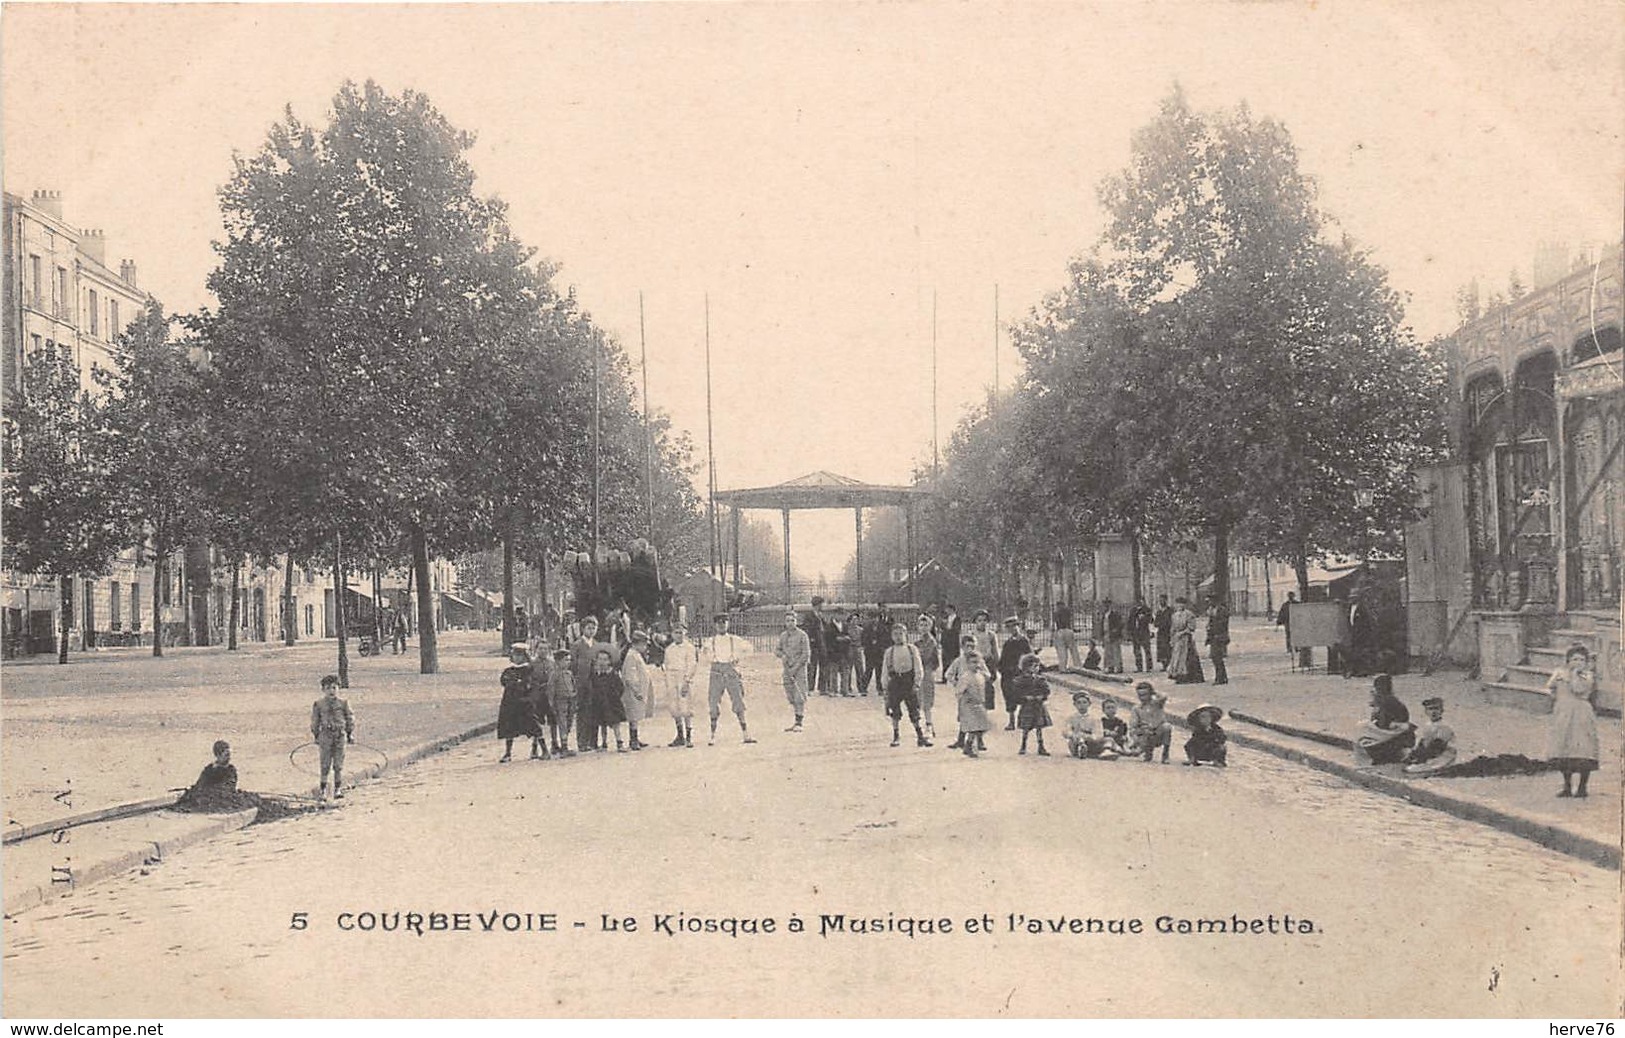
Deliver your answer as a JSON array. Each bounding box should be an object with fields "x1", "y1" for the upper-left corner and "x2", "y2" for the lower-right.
[{"x1": 928, "y1": 93, "x2": 1446, "y2": 610}]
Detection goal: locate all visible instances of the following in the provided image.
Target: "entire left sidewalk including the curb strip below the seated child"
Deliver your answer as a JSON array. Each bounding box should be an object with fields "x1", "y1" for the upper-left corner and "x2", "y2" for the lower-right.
[{"x1": 0, "y1": 634, "x2": 505, "y2": 915}]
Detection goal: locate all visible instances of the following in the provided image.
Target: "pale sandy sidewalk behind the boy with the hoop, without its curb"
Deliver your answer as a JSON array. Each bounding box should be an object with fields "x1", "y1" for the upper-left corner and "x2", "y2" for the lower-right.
[{"x1": 0, "y1": 632, "x2": 505, "y2": 830}]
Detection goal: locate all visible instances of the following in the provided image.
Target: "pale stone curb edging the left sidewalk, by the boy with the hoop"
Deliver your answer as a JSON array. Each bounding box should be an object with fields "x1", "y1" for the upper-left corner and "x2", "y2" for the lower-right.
[{"x1": 3, "y1": 721, "x2": 497, "y2": 916}]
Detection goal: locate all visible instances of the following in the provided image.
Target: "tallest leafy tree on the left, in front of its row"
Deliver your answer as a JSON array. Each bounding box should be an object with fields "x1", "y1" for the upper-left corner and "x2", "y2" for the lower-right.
[{"x1": 208, "y1": 81, "x2": 536, "y2": 676}]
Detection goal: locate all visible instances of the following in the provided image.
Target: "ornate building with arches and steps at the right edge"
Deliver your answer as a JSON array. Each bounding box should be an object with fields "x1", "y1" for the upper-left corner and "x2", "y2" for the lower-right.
[{"x1": 1409, "y1": 245, "x2": 1625, "y2": 710}]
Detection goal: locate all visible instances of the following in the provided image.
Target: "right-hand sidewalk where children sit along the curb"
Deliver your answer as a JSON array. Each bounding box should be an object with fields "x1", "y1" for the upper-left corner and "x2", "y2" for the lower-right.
[{"x1": 1047, "y1": 622, "x2": 1622, "y2": 869}]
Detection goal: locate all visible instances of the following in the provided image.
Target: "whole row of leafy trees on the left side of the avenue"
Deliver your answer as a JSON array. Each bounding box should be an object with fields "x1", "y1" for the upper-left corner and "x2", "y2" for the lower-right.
[{"x1": 5, "y1": 83, "x2": 707, "y2": 676}]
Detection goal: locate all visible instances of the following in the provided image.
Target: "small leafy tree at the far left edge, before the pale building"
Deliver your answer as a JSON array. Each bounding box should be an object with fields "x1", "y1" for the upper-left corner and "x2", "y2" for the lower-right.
[{"x1": 0, "y1": 346, "x2": 126, "y2": 663}]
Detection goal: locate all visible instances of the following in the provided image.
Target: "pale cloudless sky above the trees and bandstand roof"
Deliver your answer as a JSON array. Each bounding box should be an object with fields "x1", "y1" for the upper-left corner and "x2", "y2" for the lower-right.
[{"x1": 0, "y1": 0, "x2": 1625, "y2": 577}]
